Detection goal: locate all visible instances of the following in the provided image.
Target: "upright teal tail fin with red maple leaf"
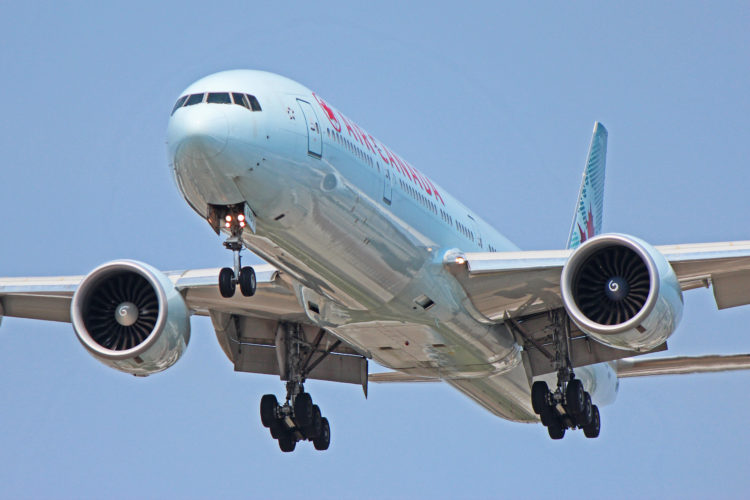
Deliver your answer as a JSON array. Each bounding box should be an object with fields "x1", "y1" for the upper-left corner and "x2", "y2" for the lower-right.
[{"x1": 568, "y1": 122, "x2": 607, "y2": 248}]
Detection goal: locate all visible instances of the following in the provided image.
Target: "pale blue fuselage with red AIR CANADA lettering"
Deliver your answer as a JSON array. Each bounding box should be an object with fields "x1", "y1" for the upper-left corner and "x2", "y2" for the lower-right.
[{"x1": 168, "y1": 71, "x2": 612, "y2": 421}]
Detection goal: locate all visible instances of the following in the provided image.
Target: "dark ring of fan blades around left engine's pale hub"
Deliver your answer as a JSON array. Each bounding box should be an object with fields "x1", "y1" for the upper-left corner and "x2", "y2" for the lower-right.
[{"x1": 84, "y1": 272, "x2": 159, "y2": 351}]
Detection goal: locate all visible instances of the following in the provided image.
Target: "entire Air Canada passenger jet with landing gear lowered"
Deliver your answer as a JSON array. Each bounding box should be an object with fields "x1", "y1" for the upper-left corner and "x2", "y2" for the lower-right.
[{"x1": 0, "y1": 70, "x2": 750, "y2": 452}]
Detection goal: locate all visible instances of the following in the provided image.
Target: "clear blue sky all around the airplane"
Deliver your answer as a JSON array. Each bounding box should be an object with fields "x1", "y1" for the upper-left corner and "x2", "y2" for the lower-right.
[{"x1": 0, "y1": 1, "x2": 750, "y2": 498}]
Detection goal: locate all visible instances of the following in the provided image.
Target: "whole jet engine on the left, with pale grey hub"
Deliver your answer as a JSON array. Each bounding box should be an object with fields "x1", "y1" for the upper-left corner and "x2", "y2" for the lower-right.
[{"x1": 71, "y1": 260, "x2": 190, "y2": 376}]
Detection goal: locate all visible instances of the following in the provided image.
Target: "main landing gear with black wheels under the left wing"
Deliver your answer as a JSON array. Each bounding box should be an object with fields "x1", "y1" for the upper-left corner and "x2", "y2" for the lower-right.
[{"x1": 260, "y1": 324, "x2": 340, "y2": 452}]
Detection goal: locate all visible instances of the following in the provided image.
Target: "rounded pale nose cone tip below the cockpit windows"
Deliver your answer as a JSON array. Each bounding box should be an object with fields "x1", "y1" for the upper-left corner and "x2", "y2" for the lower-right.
[{"x1": 167, "y1": 104, "x2": 229, "y2": 160}]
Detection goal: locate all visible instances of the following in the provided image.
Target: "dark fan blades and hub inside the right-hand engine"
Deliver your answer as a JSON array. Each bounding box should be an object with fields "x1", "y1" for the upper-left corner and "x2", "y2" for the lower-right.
[{"x1": 574, "y1": 246, "x2": 650, "y2": 325}]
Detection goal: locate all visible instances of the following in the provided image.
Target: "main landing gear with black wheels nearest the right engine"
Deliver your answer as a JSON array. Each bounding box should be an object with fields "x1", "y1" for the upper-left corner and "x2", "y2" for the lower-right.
[{"x1": 531, "y1": 313, "x2": 601, "y2": 439}]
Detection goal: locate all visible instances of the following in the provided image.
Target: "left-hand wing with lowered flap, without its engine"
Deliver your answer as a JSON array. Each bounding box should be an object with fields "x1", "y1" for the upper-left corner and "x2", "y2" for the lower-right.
[{"x1": 0, "y1": 265, "x2": 367, "y2": 391}]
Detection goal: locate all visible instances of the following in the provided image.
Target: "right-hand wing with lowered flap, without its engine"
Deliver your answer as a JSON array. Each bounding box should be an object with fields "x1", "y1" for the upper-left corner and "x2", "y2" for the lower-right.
[{"x1": 445, "y1": 241, "x2": 750, "y2": 376}]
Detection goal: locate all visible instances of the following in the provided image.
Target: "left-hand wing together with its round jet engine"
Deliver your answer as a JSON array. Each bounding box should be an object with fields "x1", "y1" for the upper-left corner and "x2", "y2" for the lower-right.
[{"x1": 0, "y1": 261, "x2": 367, "y2": 392}]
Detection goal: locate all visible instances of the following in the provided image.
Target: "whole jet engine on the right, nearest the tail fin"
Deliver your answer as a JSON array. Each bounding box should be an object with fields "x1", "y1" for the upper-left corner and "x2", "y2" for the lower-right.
[{"x1": 560, "y1": 234, "x2": 683, "y2": 352}]
